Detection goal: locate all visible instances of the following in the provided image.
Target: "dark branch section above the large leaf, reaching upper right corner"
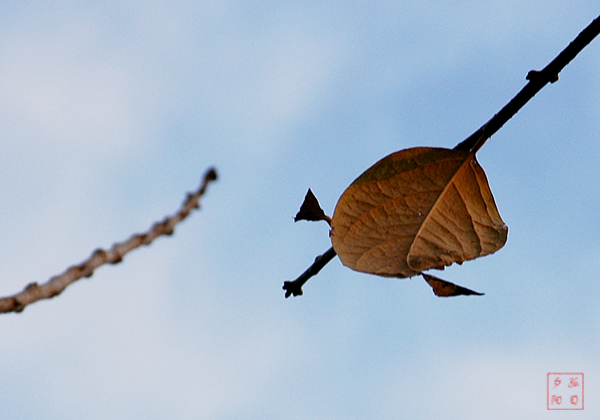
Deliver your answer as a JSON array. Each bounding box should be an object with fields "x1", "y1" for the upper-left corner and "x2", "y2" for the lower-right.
[{"x1": 454, "y1": 16, "x2": 600, "y2": 153}]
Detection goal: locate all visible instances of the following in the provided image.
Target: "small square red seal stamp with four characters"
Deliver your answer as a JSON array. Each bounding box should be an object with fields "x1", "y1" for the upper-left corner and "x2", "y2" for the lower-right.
[{"x1": 546, "y1": 372, "x2": 583, "y2": 410}]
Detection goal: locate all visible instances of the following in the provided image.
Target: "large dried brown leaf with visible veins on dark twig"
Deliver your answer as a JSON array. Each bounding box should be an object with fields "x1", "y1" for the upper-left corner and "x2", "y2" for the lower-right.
[{"x1": 331, "y1": 147, "x2": 508, "y2": 277}]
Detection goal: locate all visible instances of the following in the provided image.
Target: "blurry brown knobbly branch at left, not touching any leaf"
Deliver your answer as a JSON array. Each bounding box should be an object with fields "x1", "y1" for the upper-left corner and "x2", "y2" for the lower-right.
[{"x1": 0, "y1": 168, "x2": 217, "y2": 313}]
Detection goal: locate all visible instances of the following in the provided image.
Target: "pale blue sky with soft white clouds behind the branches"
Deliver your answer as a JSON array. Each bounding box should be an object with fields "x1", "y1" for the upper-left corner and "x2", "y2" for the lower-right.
[{"x1": 0, "y1": 0, "x2": 600, "y2": 420}]
